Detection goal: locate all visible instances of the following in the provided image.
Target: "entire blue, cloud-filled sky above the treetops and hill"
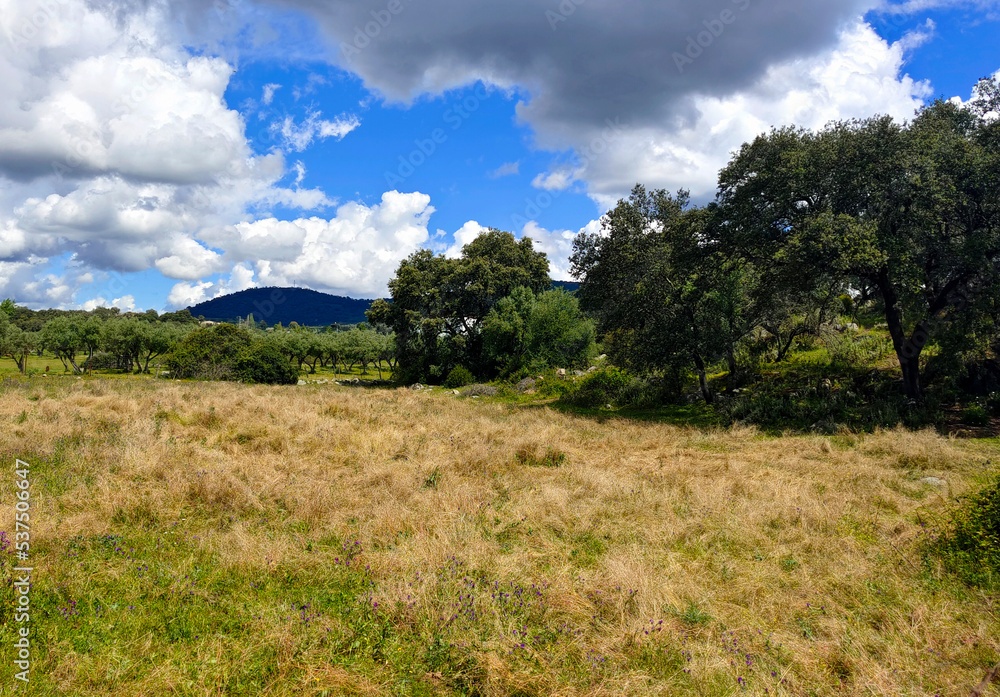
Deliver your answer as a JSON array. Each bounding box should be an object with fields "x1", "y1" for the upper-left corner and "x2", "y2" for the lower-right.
[{"x1": 0, "y1": 0, "x2": 1000, "y2": 310}]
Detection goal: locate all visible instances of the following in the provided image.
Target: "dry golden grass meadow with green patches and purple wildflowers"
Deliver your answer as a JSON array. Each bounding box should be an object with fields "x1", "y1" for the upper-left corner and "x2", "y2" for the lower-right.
[{"x1": 0, "y1": 378, "x2": 1000, "y2": 697}]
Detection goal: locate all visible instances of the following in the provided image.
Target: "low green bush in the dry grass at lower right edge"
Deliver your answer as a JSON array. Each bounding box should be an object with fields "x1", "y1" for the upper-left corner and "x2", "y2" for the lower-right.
[{"x1": 936, "y1": 478, "x2": 1000, "y2": 587}]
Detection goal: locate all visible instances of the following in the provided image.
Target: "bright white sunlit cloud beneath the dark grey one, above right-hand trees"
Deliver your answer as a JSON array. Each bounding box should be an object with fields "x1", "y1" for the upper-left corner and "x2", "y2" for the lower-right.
[{"x1": 576, "y1": 20, "x2": 931, "y2": 207}]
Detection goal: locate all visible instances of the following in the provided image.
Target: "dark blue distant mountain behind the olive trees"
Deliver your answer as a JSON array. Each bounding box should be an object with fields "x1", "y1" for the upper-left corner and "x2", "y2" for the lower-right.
[{"x1": 188, "y1": 288, "x2": 373, "y2": 327}]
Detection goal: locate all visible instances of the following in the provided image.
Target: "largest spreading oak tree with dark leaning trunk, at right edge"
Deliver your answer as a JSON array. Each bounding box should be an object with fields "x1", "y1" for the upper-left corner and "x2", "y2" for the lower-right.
[{"x1": 719, "y1": 93, "x2": 1000, "y2": 400}]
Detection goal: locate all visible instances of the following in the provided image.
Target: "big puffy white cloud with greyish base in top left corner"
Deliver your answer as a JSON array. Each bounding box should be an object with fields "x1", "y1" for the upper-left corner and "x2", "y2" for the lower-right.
[{"x1": 0, "y1": 0, "x2": 249, "y2": 184}]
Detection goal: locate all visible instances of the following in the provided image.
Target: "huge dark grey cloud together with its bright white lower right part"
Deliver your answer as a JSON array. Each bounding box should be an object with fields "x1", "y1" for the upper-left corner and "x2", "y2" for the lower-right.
[{"x1": 270, "y1": 0, "x2": 932, "y2": 206}]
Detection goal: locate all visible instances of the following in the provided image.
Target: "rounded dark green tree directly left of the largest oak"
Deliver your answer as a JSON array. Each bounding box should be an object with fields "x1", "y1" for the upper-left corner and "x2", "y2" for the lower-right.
[{"x1": 572, "y1": 186, "x2": 779, "y2": 403}]
